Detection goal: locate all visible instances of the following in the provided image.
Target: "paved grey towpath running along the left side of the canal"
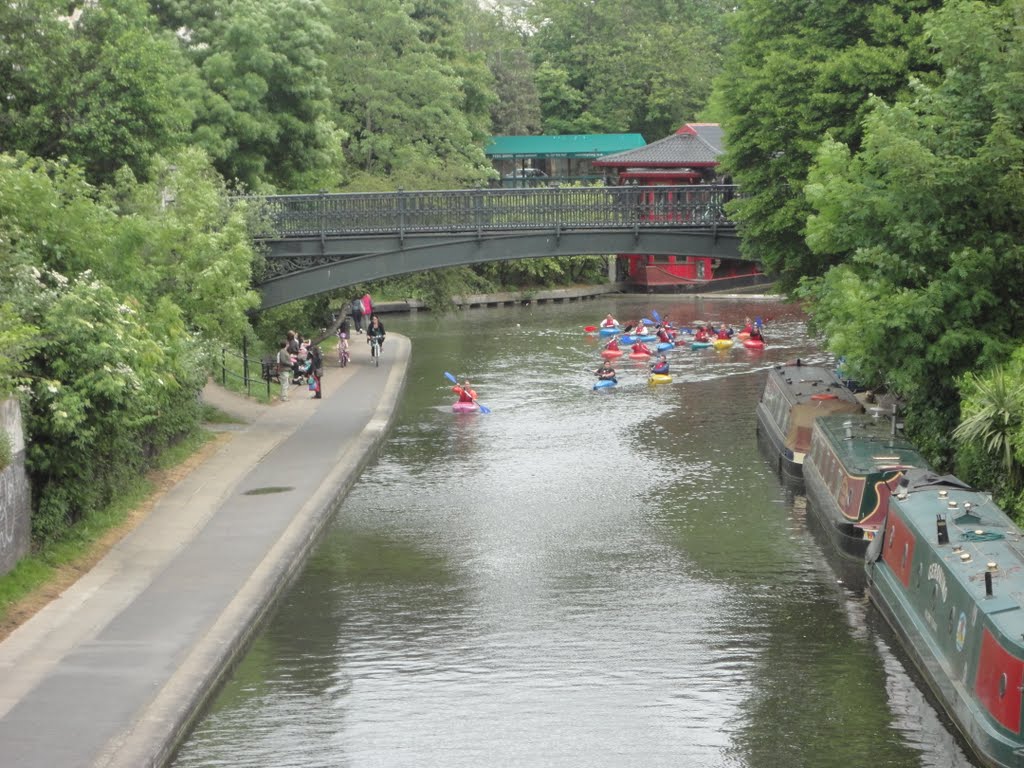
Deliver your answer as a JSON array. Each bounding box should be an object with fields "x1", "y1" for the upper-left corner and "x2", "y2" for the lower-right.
[{"x1": 0, "y1": 334, "x2": 410, "y2": 768}]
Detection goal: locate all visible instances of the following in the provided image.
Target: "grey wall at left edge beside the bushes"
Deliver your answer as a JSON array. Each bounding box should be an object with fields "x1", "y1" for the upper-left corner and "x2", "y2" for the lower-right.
[{"x1": 0, "y1": 397, "x2": 32, "y2": 575}]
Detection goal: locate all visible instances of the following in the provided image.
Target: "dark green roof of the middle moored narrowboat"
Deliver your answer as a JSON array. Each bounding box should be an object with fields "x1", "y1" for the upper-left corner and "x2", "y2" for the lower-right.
[{"x1": 812, "y1": 414, "x2": 929, "y2": 475}]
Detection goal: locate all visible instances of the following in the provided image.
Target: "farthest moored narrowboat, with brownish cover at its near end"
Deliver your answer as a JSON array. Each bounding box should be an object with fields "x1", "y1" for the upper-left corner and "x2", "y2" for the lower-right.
[{"x1": 757, "y1": 359, "x2": 864, "y2": 486}]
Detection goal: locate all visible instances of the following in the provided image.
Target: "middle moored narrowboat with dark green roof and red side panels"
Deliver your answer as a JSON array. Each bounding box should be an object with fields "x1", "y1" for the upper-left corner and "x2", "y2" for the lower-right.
[{"x1": 804, "y1": 413, "x2": 929, "y2": 560}]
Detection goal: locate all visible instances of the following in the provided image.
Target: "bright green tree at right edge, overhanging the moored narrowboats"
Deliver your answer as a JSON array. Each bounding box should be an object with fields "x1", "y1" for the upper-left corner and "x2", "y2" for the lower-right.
[{"x1": 806, "y1": 0, "x2": 1024, "y2": 466}]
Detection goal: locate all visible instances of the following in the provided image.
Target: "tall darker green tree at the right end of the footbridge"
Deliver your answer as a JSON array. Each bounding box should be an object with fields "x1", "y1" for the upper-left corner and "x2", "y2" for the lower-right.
[{"x1": 714, "y1": 0, "x2": 942, "y2": 291}]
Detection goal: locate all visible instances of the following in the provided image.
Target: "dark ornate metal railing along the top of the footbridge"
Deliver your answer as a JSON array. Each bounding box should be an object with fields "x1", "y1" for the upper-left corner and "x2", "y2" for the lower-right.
[{"x1": 237, "y1": 184, "x2": 736, "y2": 240}]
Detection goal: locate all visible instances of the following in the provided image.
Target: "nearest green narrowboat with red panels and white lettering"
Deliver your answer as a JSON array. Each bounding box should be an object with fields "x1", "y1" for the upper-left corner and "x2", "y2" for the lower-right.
[{"x1": 864, "y1": 469, "x2": 1024, "y2": 768}]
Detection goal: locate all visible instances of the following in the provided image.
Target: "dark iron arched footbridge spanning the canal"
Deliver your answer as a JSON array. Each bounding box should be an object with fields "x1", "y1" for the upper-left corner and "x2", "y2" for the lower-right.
[{"x1": 234, "y1": 184, "x2": 740, "y2": 308}]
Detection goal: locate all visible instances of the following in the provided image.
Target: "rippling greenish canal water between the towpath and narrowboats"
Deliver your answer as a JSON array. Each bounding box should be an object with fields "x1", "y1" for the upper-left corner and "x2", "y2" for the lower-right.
[{"x1": 173, "y1": 296, "x2": 974, "y2": 768}]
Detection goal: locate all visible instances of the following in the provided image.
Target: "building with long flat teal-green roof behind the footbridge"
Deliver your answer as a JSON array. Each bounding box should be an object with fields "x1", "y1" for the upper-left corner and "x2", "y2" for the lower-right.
[{"x1": 484, "y1": 133, "x2": 646, "y2": 186}]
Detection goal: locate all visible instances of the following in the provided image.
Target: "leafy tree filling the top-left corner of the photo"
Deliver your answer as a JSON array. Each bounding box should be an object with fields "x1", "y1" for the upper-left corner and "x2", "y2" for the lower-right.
[{"x1": 0, "y1": 0, "x2": 201, "y2": 182}]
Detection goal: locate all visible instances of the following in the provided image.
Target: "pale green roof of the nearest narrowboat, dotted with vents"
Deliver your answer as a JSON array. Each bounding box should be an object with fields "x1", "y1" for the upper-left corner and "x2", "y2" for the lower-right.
[{"x1": 891, "y1": 469, "x2": 1024, "y2": 645}]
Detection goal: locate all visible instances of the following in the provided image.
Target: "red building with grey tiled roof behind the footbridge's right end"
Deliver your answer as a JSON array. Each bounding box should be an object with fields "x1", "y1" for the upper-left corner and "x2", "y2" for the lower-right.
[{"x1": 593, "y1": 123, "x2": 767, "y2": 293}]
